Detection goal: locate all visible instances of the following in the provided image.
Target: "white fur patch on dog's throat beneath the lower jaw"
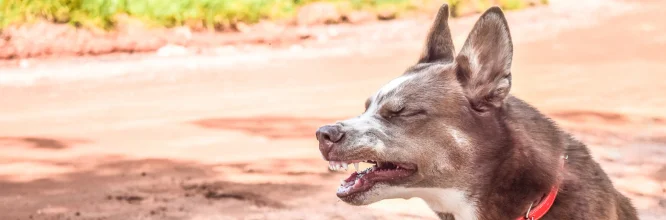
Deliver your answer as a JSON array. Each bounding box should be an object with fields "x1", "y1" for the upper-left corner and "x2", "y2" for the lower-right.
[{"x1": 372, "y1": 186, "x2": 478, "y2": 220}]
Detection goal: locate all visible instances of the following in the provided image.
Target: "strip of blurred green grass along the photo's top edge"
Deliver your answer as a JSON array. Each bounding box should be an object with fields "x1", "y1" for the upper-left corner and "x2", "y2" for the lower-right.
[{"x1": 0, "y1": 0, "x2": 540, "y2": 30}]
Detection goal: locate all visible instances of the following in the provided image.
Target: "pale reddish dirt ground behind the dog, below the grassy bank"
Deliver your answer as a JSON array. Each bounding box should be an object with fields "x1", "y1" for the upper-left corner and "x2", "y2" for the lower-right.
[{"x1": 0, "y1": 0, "x2": 666, "y2": 220}]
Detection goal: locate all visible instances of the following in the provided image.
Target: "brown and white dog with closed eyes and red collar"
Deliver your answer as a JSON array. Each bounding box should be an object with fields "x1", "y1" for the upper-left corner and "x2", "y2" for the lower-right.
[{"x1": 316, "y1": 4, "x2": 638, "y2": 220}]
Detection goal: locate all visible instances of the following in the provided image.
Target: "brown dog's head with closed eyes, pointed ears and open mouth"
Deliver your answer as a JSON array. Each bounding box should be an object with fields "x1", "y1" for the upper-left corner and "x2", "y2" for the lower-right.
[{"x1": 316, "y1": 5, "x2": 513, "y2": 205}]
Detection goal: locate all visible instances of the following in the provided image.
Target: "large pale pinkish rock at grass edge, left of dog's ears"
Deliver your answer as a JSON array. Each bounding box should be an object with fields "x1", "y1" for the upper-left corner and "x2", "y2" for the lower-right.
[{"x1": 296, "y1": 2, "x2": 341, "y2": 25}]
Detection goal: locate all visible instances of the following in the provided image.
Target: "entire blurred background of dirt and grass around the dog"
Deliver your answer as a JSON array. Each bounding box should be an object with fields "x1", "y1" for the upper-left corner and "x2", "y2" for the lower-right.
[{"x1": 0, "y1": 0, "x2": 666, "y2": 220}]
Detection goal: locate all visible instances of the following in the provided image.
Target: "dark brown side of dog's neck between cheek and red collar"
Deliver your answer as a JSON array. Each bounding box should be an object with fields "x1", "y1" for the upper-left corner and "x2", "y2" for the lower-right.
[{"x1": 471, "y1": 125, "x2": 561, "y2": 219}]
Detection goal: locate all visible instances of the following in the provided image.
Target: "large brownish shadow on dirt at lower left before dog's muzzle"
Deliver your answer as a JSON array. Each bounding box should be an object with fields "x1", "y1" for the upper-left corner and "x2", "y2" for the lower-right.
[{"x1": 0, "y1": 156, "x2": 330, "y2": 219}]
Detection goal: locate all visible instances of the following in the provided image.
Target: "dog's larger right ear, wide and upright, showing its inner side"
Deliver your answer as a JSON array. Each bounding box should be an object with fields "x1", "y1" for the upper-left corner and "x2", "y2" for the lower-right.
[{"x1": 456, "y1": 6, "x2": 513, "y2": 111}]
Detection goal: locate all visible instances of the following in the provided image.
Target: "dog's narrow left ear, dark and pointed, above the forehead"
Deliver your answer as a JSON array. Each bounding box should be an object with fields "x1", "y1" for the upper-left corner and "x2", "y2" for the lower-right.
[{"x1": 419, "y1": 4, "x2": 455, "y2": 63}]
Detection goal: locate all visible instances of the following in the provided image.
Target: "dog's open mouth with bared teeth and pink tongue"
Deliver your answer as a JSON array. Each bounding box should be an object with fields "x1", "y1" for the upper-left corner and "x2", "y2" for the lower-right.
[{"x1": 329, "y1": 160, "x2": 416, "y2": 198}]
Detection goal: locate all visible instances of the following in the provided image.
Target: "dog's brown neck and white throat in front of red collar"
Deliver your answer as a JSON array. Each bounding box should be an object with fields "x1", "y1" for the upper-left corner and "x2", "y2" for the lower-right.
[{"x1": 420, "y1": 122, "x2": 563, "y2": 220}]
